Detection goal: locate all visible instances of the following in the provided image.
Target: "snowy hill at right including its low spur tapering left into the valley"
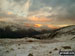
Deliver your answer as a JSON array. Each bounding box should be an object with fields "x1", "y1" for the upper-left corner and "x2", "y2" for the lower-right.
[{"x1": 33, "y1": 25, "x2": 75, "y2": 40}]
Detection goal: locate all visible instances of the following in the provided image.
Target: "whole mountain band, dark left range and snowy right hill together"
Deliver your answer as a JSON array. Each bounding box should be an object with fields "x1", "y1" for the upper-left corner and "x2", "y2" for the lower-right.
[{"x1": 0, "y1": 22, "x2": 75, "y2": 40}]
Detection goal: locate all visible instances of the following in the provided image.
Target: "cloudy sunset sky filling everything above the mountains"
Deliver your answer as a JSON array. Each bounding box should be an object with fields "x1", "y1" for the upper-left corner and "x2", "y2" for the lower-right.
[{"x1": 0, "y1": 0, "x2": 75, "y2": 28}]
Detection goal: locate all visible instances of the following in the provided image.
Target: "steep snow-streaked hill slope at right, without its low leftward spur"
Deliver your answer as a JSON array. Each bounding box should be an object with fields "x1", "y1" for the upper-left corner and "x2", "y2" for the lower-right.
[{"x1": 49, "y1": 25, "x2": 75, "y2": 41}]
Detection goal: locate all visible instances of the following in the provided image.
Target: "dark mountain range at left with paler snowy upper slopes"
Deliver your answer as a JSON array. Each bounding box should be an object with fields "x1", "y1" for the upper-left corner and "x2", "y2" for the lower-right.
[{"x1": 0, "y1": 22, "x2": 50, "y2": 38}]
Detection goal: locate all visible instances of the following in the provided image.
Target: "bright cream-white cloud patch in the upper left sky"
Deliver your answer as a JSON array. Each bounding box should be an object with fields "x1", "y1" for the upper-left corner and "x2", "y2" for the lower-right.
[{"x1": 0, "y1": 0, "x2": 31, "y2": 17}]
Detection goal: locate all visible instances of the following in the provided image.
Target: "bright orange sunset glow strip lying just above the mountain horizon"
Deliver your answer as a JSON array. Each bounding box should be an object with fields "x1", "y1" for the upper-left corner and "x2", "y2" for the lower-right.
[{"x1": 24, "y1": 23, "x2": 68, "y2": 29}]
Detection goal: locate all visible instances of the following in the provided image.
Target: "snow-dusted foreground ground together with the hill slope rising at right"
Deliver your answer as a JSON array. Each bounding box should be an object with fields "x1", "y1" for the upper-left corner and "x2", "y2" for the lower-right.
[{"x1": 0, "y1": 26, "x2": 75, "y2": 56}]
